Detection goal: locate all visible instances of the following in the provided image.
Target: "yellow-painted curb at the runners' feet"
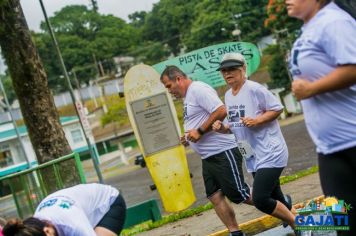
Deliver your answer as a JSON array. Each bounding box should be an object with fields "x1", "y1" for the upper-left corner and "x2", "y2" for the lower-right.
[{"x1": 209, "y1": 195, "x2": 324, "y2": 236}]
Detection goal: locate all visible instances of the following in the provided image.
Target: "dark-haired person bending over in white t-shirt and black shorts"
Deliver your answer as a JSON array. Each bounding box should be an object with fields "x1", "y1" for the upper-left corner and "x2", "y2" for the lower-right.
[{"x1": 3, "y1": 184, "x2": 126, "y2": 236}]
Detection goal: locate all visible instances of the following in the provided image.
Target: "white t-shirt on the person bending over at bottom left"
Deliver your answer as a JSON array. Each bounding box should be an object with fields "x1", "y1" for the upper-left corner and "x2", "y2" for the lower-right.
[{"x1": 34, "y1": 183, "x2": 119, "y2": 236}]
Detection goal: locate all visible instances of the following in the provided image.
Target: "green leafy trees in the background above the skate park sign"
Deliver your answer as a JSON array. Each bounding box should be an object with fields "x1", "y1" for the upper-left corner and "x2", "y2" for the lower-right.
[{"x1": 0, "y1": 0, "x2": 306, "y2": 128}]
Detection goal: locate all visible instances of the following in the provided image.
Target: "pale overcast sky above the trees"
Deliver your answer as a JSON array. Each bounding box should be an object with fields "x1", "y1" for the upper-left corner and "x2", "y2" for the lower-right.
[{"x1": 0, "y1": 0, "x2": 159, "y2": 74}]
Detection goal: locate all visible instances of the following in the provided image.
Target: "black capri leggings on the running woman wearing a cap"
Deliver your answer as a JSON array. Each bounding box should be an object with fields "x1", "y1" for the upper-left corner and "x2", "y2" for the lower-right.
[{"x1": 252, "y1": 168, "x2": 292, "y2": 215}]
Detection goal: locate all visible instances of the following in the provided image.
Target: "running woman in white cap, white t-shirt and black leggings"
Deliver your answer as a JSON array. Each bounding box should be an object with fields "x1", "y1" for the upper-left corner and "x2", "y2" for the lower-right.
[{"x1": 213, "y1": 53, "x2": 294, "y2": 228}]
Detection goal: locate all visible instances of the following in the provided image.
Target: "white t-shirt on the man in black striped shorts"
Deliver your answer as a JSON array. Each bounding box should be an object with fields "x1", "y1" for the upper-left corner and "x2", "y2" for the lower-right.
[{"x1": 183, "y1": 81, "x2": 237, "y2": 159}]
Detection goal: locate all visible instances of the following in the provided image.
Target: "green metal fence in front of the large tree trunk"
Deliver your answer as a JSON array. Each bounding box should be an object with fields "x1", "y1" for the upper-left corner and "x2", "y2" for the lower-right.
[{"x1": 0, "y1": 153, "x2": 86, "y2": 218}]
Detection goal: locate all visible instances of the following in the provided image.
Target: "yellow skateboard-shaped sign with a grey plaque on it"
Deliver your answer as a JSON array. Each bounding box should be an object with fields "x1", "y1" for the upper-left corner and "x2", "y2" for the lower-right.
[{"x1": 124, "y1": 64, "x2": 195, "y2": 212}]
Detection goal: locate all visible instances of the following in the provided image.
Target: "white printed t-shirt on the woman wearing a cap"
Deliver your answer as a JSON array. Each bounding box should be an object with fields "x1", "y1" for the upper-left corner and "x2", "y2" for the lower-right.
[{"x1": 225, "y1": 80, "x2": 288, "y2": 172}]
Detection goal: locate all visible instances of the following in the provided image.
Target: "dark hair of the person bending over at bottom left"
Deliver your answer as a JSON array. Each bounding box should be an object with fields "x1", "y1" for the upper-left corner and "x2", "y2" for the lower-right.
[{"x1": 2, "y1": 217, "x2": 47, "y2": 236}]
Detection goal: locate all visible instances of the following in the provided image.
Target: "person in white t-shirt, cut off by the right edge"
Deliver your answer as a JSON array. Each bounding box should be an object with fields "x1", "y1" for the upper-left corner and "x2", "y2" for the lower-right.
[{"x1": 285, "y1": 0, "x2": 356, "y2": 235}]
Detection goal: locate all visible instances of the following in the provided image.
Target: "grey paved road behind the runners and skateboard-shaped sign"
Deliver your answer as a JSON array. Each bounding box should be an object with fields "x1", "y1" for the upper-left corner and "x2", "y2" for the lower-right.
[{"x1": 105, "y1": 121, "x2": 317, "y2": 213}]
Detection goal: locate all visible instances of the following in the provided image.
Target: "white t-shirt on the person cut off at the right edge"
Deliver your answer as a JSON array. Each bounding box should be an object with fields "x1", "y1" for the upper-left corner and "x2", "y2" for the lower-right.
[{"x1": 289, "y1": 2, "x2": 356, "y2": 154}]
